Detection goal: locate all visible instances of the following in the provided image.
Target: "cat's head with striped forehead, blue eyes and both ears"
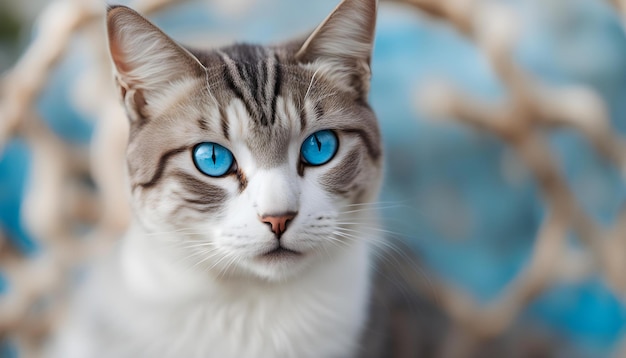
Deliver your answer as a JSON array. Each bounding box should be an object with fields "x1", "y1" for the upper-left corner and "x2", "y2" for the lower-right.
[{"x1": 107, "y1": 0, "x2": 382, "y2": 280}]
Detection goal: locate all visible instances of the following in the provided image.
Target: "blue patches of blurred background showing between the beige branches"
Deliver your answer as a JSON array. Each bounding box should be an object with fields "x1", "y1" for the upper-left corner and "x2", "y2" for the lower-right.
[{"x1": 0, "y1": 0, "x2": 626, "y2": 357}]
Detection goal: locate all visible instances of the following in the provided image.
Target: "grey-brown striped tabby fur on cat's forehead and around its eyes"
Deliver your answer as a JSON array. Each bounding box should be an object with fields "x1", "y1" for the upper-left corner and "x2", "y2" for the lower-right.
[{"x1": 115, "y1": 18, "x2": 381, "y2": 215}]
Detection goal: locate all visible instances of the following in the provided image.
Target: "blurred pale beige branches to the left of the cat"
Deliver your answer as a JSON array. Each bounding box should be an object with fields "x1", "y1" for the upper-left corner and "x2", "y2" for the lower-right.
[{"x1": 0, "y1": 0, "x2": 188, "y2": 354}]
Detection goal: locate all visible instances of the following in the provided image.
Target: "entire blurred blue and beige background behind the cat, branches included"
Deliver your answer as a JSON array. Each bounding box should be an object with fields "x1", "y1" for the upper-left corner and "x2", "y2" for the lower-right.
[{"x1": 0, "y1": 0, "x2": 626, "y2": 358}]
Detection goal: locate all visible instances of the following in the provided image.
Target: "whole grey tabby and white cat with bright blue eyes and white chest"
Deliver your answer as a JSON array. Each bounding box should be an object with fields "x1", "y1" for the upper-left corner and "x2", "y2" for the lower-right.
[{"x1": 51, "y1": 0, "x2": 384, "y2": 358}]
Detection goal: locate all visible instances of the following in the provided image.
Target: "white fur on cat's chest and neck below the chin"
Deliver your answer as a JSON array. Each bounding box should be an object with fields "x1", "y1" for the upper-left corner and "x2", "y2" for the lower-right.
[{"x1": 51, "y1": 221, "x2": 369, "y2": 358}]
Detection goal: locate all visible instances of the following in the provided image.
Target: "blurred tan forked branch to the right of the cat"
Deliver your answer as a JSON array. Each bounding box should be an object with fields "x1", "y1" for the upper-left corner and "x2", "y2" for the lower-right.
[{"x1": 399, "y1": 0, "x2": 626, "y2": 350}]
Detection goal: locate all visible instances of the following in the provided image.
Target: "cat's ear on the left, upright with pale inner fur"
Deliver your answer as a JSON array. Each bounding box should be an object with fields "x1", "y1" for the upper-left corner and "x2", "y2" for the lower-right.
[{"x1": 106, "y1": 6, "x2": 206, "y2": 121}]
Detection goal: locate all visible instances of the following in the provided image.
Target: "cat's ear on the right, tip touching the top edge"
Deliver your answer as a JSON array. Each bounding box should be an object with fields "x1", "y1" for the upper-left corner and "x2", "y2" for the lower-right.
[{"x1": 296, "y1": 0, "x2": 378, "y2": 96}]
